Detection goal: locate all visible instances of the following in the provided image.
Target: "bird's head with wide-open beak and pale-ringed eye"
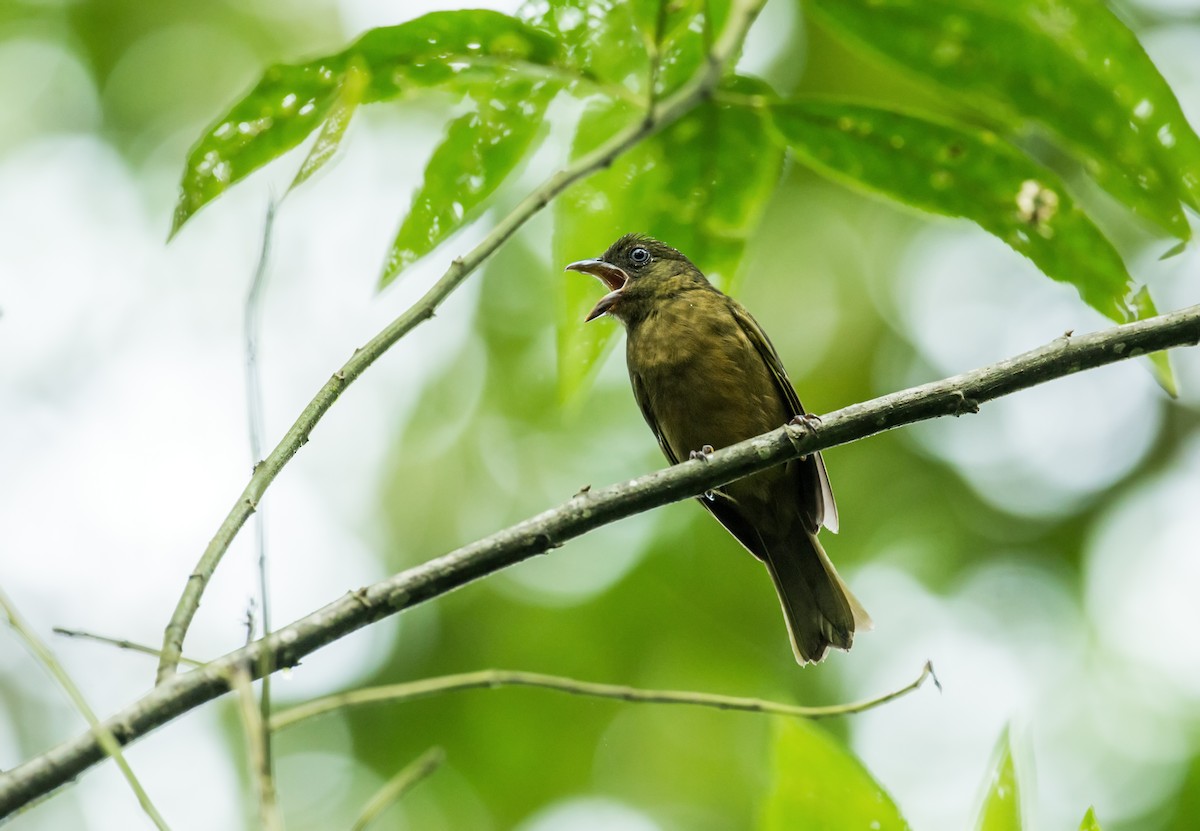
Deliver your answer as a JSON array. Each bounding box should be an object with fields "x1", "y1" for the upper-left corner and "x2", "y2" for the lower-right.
[{"x1": 566, "y1": 234, "x2": 708, "y2": 324}]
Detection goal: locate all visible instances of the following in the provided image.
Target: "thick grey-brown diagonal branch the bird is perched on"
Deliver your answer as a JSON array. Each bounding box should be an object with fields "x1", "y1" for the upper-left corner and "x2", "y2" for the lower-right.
[{"x1": 0, "y1": 300, "x2": 1200, "y2": 819}]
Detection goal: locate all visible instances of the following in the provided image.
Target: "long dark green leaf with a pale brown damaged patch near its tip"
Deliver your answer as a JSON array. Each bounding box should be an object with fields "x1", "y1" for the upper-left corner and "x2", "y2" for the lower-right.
[{"x1": 772, "y1": 101, "x2": 1145, "y2": 322}]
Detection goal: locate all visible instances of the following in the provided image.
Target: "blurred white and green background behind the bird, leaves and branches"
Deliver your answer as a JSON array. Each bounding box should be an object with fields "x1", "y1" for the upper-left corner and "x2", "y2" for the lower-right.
[{"x1": 0, "y1": 0, "x2": 1200, "y2": 831}]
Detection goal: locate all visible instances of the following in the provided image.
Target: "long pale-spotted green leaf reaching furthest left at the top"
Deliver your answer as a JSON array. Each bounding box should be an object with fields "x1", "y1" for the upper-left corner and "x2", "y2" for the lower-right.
[{"x1": 172, "y1": 11, "x2": 562, "y2": 234}]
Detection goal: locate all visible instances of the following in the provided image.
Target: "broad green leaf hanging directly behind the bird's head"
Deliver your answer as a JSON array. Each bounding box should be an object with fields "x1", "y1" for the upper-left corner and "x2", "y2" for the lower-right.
[{"x1": 553, "y1": 79, "x2": 784, "y2": 401}]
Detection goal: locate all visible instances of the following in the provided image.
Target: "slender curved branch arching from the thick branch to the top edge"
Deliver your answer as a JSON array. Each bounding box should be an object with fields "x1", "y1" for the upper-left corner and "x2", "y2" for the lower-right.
[{"x1": 157, "y1": 0, "x2": 766, "y2": 683}]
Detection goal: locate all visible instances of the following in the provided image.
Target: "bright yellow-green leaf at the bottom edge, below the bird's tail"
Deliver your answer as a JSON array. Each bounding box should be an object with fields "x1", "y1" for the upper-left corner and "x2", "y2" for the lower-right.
[{"x1": 760, "y1": 719, "x2": 908, "y2": 831}]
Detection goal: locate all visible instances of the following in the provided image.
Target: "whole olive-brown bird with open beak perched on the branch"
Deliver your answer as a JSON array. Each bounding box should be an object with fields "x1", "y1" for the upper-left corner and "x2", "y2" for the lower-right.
[{"x1": 566, "y1": 234, "x2": 870, "y2": 664}]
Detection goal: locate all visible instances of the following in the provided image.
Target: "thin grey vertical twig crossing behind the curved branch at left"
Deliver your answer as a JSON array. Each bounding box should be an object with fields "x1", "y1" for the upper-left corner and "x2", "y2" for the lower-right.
[{"x1": 242, "y1": 198, "x2": 278, "y2": 771}]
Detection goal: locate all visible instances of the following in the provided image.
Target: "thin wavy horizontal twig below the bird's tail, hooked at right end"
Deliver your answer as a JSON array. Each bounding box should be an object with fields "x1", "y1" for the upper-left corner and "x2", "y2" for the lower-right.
[{"x1": 271, "y1": 663, "x2": 934, "y2": 730}]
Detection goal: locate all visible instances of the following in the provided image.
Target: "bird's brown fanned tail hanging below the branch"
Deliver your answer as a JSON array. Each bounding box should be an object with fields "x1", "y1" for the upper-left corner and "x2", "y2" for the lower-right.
[{"x1": 766, "y1": 531, "x2": 871, "y2": 664}]
